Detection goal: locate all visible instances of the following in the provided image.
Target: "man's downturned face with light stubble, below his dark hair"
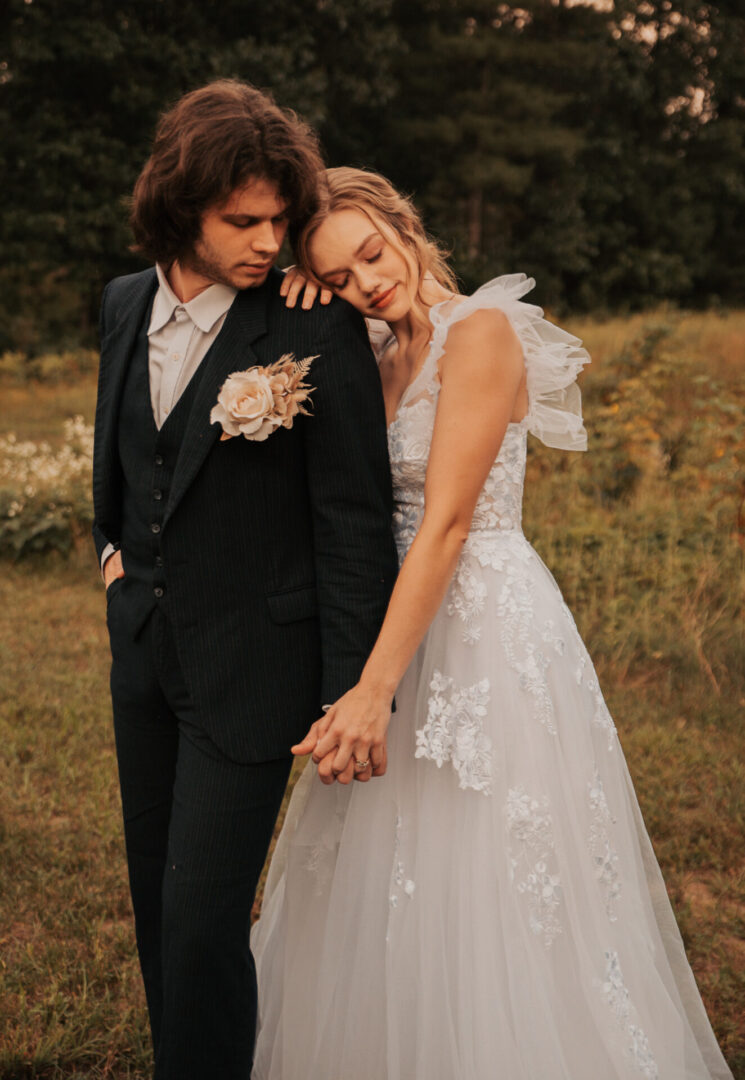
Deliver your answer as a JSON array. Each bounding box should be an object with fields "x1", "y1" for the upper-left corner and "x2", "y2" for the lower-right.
[{"x1": 184, "y1": 178, "x2": 288, "y2": 288}]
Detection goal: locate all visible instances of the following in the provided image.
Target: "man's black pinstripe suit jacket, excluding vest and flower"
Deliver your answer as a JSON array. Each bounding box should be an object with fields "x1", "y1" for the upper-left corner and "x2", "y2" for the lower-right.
[{"x1": 93, "y1": 270, "x2": 396, "y2": 761}]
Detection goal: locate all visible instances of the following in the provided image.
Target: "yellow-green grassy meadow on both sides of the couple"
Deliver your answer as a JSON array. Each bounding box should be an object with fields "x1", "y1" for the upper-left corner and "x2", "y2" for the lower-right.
[{"x1": 0, "y1": 311, "x2": 745, "y2": 1080}]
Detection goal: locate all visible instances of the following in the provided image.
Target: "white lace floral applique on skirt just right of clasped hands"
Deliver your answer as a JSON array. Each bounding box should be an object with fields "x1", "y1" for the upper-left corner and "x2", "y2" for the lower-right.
[{"x1": 416, "y1": 670, "x2": 491, "y2": 795}]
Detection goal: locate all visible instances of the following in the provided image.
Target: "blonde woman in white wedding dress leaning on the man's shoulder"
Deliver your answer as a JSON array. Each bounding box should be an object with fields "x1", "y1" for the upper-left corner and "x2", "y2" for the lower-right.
[{"x1": 252, "y1": 168, "x2": 731, "y2": 1080}]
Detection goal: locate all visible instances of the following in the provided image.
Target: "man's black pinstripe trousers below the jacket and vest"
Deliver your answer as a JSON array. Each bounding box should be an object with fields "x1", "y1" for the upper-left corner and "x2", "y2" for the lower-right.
[{"x1": 108, "y1": 592, "x2": 292, "y2": 1080}]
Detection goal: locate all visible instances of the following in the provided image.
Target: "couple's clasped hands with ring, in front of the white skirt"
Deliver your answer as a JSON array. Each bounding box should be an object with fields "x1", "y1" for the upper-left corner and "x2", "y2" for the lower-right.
[{"x1": 292, "y1": 683, "x2": 391, "y2": 784}]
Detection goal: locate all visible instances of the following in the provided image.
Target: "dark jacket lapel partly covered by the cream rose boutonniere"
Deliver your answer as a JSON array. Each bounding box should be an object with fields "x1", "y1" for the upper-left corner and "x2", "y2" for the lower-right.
[{"x1": 163, "y1": 287, "x2": 269, "y2": 525}]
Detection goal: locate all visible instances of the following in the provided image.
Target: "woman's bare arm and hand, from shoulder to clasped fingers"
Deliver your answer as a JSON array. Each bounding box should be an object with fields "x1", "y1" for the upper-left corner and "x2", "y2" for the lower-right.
[{"x1": 293, "y1": 310, "x2": 525, "y2": 783}]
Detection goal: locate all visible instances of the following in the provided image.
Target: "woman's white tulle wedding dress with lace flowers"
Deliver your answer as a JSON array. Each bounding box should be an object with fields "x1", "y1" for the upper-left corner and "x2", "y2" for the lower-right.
[{"x1": 252, "y1": 274, "x2": 731, "y2": 1080}]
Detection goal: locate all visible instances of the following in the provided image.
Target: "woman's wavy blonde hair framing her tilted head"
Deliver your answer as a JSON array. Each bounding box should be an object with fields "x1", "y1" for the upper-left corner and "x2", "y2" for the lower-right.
[{"x1": 296, "y1": 166, "x2": 458, "y2": 311}]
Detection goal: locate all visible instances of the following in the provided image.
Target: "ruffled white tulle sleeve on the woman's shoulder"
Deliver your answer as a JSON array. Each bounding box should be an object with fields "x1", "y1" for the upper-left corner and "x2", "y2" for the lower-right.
[{"x1": 433, "y1": 273, "x2": 590, "y2": 450}]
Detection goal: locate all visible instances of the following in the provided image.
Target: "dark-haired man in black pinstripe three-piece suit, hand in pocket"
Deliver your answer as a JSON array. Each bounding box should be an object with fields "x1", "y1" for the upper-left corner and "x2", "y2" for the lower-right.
[{"x1": 93, "y1": 81, "x2": 396, "y2": 1080}]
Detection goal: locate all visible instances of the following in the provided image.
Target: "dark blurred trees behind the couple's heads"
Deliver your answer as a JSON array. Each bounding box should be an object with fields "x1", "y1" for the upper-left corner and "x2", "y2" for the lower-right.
[{"x1": 0, "y1": 0, "x2": 745, "y2": 354}]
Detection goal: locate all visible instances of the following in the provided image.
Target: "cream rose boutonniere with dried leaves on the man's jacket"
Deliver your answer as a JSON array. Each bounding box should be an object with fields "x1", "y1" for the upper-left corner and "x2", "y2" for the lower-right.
[{"x1": 209, "y1": 352, "x2": 317, "y2": 443}]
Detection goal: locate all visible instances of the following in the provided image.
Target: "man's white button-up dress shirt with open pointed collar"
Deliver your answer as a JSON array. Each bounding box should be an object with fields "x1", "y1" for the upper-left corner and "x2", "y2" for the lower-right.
[{"x1": 100, "y1": 265, "x2": 238, "y2": 571}]
